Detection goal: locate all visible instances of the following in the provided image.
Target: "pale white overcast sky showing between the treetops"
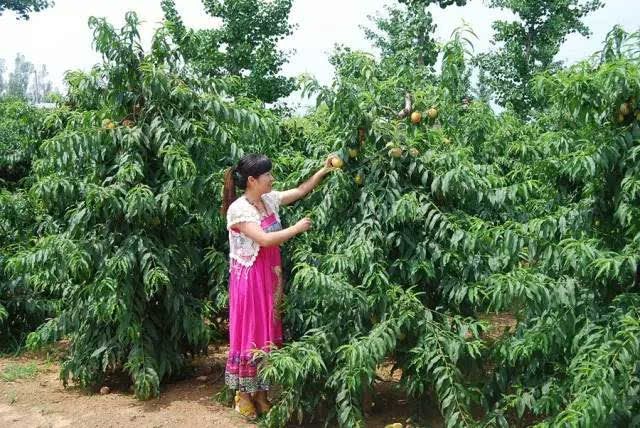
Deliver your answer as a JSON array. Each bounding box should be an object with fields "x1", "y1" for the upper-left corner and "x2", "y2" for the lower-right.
[{"x1": 0, "y1": 0, "x2": 640, "y2": 107}]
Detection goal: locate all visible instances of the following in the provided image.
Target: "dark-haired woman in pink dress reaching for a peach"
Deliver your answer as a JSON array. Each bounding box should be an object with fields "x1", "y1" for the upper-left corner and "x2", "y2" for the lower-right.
[{"x1": 222, "y1": 155, "x2": 333, "y2": 418}]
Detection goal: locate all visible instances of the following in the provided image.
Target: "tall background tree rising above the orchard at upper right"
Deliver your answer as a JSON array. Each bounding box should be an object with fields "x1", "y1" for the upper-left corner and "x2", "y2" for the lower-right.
[{"x1": 477, "y1": 0, "x2": 603, "y2": 115}]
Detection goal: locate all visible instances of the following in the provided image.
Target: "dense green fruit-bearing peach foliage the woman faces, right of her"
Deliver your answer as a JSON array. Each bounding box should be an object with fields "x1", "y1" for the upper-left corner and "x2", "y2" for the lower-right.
[{"x1": 255, "y1": 27, "x2": 640, "y2": 426}]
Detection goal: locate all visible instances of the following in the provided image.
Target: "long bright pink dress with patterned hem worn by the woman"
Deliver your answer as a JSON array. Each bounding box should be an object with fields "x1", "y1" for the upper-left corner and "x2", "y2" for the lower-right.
[{"x1": 225, "y1": 213, "x2": 283, "y2": 393}]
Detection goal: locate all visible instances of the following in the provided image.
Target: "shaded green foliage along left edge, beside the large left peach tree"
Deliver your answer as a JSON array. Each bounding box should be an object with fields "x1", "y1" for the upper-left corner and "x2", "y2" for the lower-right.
[{"x1": 0, "y1": 98, "x2": 56, "y2": 352}]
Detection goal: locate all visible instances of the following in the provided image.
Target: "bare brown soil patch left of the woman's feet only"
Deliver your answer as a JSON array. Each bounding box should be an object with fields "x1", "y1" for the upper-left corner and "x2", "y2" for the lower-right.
[{"x1": 0, "y1": 349, "x2": 253, "y2": 428}]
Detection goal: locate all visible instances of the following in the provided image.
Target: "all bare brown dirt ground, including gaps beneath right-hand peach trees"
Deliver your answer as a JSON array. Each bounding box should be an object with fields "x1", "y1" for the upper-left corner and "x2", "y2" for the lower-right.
[{"x1": 0, "y1": 316, "x2": 515, "y2": 428}]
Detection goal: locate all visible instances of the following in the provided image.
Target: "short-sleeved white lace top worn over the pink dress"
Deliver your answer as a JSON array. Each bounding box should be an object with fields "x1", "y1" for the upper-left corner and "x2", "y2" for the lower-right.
[{"x1": 227, "y1": 191, "x2": 280, "y2": 267}]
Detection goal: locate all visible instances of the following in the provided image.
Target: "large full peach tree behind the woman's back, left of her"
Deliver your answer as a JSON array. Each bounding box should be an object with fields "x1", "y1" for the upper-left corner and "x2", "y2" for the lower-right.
[{"x1": 2, "y1": 14, "x2": 276, "y2": 398}]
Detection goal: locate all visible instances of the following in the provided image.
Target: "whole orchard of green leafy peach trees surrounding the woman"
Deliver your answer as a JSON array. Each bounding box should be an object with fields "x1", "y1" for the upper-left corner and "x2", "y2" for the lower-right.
[{"x1": 0, "y1": 0, "x2": 640, "y2": 427}]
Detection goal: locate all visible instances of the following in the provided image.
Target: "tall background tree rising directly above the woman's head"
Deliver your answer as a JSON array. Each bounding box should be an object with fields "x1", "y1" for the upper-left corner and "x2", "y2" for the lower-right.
[{"x1": 162, "y1": 0, "x2": 295, "y2": 103}]
